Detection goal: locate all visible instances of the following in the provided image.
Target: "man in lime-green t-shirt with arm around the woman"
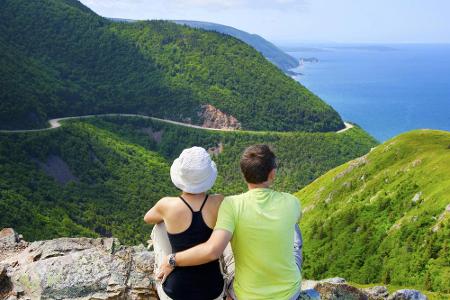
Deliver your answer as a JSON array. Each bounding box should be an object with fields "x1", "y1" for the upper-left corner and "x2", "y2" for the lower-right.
[{"x1": 159, "y1": 145, "x2": 301, "y2": 300}]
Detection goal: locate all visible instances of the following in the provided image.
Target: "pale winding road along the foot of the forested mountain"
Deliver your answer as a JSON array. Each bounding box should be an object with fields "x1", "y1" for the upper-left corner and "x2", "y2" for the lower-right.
[{"x1": 0, "y1": 114, "x2": 354, "y2": 133}]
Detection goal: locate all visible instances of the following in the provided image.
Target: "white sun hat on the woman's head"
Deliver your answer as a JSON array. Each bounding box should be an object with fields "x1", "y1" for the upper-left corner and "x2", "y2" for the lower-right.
[{"x1": 170, "y1": 147, "x2": 217, "y2": 194}]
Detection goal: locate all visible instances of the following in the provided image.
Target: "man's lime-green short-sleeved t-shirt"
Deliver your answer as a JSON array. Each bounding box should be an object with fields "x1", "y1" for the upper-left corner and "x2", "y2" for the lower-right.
[{"x1": 215, "y1": 188, "x2": 301, "y2": 300}]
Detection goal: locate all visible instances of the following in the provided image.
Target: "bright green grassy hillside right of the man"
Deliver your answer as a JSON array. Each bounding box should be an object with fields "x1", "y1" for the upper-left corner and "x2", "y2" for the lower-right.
[{"x1": 297, "y1": 130, "x2": 450, "y2": 293}]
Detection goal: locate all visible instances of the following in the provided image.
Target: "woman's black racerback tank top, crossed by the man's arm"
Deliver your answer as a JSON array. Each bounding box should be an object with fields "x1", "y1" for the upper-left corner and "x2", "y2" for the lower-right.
[{"x1": 163, "y1": 195, "x2": 224, "y2": 300}]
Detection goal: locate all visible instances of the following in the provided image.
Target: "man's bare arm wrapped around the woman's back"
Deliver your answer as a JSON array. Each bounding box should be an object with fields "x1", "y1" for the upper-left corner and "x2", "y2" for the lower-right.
[{"x1": 158, "y1": 229, "x2": 232, "y2": 281}]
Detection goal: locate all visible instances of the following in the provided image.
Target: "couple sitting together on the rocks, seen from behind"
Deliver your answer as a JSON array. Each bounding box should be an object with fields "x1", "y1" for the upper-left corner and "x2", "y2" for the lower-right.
[{"x1": 144, "y1": 145, "x2": 302, "y2": 300}]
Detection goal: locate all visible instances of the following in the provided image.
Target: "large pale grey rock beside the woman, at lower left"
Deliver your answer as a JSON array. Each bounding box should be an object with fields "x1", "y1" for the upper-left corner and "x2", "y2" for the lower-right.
[{"x1": 0, "y1": 238, "x2": 157, "y2": 299}]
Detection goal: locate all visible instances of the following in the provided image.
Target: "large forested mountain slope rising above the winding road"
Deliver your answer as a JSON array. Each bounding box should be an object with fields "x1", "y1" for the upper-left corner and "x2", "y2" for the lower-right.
[{"x1": 0, "y1": 0, "x2": 343, "y2": 131}]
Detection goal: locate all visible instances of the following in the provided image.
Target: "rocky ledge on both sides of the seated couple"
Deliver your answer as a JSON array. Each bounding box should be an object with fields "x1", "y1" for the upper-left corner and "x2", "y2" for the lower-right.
[{"x1": 0, "y1": 228, "x2": 427, "y2": 300}]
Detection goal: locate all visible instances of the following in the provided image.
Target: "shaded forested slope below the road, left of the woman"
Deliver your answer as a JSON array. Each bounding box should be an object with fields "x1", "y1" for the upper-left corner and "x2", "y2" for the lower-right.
[{"x1": 0, "y1": 123, "x2": 176, "y2": 242}]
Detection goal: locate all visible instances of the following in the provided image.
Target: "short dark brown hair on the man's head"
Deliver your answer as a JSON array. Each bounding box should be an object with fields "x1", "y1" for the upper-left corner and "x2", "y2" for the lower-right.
[{"x1": 240, "y1": 145, "x2": 277, "y2": 184}]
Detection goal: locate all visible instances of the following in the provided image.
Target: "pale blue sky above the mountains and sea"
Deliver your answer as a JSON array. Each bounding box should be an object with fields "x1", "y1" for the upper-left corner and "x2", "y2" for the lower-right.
[{"x1": 81, "y1": 0, "x2": 450, "y2": 45}]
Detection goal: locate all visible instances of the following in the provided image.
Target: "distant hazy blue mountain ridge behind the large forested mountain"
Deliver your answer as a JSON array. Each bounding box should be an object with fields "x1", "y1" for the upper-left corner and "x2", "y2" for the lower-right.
[{"x1": 174, "y1": 20, "x2": 299, "y2": 72}]
